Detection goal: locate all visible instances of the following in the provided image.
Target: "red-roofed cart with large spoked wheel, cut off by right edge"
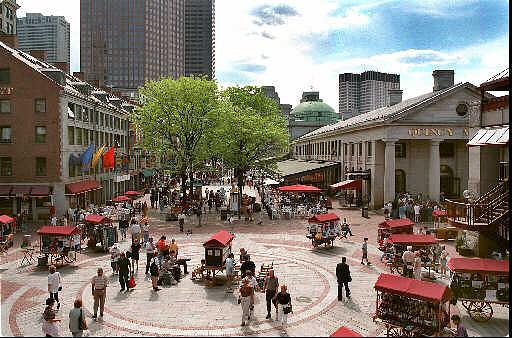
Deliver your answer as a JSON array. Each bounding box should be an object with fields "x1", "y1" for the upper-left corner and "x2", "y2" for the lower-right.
[{"x1": 448, "y1": 257, "x2": 510, "y2": 322}]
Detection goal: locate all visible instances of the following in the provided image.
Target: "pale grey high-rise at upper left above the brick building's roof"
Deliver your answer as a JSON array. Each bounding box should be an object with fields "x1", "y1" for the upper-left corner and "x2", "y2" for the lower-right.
[{"x1": 17, "y1": 13, "x2": 70, "y2": 65}]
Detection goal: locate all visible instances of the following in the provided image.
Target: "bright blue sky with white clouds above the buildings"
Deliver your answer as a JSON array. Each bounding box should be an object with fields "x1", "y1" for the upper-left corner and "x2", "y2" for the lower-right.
[{"x1": 17, "y1": 0, "x2": 509, "y2": 111}]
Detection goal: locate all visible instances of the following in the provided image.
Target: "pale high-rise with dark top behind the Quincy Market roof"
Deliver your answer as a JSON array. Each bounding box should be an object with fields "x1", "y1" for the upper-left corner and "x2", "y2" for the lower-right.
[{"x1": 339, "y1": 71, "x2": 400, "y2": 120}]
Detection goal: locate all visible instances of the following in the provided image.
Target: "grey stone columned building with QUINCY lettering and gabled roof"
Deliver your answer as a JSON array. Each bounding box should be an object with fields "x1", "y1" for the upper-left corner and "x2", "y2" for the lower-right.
[{"x1": 293, "y1": 70, "x2": 480, "y2": 209}]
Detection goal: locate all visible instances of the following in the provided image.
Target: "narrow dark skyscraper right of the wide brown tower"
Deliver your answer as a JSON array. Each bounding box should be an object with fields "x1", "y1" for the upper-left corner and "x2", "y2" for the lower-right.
[{"x1": 185, "y1": 0, "x2": 215, "y2": 79}]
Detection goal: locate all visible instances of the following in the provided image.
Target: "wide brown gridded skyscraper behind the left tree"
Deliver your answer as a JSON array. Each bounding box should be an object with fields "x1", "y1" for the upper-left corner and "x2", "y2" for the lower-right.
[{"x1": 80, "y1": 0, "x2": 185, "y2": 95}]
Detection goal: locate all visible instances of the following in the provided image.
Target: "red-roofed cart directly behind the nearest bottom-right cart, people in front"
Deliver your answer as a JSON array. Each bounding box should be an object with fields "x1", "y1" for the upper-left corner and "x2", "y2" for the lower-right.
[{"x1": 387, "y1": 234, "x2": 437, "y2": 278}]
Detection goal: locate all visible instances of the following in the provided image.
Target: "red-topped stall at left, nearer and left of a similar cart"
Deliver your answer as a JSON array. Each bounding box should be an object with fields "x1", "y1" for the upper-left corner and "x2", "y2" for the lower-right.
[{"x1": 37, "y1": 225, "x2": 80, "y2": 266}]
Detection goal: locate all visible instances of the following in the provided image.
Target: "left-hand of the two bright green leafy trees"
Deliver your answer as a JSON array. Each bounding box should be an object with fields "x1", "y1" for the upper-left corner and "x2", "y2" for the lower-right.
[{"x1": 131, "y1": 76, "x2": 222, "y2": 196}]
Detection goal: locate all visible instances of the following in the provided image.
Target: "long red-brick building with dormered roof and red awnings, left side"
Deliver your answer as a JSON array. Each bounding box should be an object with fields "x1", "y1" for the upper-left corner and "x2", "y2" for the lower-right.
[{"x1": 0, "y1": 43, "x2": 141, "y2": 221}]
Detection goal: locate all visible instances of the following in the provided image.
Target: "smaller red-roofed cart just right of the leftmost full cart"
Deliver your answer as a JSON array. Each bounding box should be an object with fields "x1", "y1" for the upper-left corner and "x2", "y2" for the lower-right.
[{"x1": 82, "y1": 214, "x2": 118, "y2": 252}]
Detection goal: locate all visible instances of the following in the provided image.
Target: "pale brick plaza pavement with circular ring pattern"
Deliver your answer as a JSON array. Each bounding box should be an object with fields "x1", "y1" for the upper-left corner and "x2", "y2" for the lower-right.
[{"x1": 0, "y1": 190, "x2": 509, "y2": 336}]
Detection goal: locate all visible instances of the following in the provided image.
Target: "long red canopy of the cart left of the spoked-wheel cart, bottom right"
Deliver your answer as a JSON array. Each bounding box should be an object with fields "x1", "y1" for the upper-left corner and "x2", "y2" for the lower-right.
[{"x1": 374, "y1": 273, "x2": 452, "y2": 303}]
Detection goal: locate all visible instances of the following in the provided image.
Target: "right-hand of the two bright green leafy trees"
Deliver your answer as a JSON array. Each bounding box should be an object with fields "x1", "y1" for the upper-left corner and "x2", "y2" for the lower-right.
[{"x1": 214, "y1": 86, "x2": 288, "y2": 218}]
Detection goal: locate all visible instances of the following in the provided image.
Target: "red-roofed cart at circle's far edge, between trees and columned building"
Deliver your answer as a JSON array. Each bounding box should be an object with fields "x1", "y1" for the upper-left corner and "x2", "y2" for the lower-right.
[{"x1": 306, "y1": 213, "x2": 341, "y2": 248}]
